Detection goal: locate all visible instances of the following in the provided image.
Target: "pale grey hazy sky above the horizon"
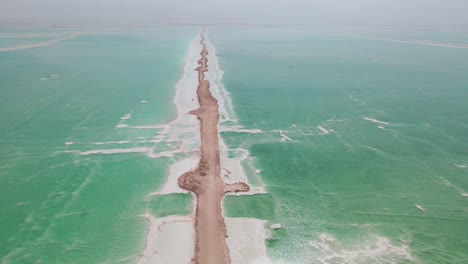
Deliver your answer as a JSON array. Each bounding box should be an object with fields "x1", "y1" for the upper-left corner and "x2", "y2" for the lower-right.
[{"x1": 0, "y1": 0, "x2": 468, "y2": 29}]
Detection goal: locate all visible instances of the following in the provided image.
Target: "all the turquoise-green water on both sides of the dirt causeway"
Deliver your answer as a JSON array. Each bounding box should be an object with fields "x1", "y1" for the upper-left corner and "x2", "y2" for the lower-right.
[{"x1": 0, "y1": 27, "x2": 468, "y2": 263}]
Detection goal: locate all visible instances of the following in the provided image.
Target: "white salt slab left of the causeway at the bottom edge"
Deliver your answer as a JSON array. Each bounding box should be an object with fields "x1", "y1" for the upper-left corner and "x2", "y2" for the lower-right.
[{"x1": 137, "y1": 213, "x2": 194, "y2": 264}]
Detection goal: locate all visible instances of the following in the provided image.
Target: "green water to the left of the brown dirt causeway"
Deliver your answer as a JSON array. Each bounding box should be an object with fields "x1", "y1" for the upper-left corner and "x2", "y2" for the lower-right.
[{"x1": 0, "y1": 28, "x2": 198, "y2": 263}]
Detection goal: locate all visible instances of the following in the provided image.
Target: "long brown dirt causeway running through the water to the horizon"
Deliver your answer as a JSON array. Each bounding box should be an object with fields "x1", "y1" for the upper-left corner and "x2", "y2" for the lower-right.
[{"x1": 178, "y1": 32, "x2": 250, "y2": 264}]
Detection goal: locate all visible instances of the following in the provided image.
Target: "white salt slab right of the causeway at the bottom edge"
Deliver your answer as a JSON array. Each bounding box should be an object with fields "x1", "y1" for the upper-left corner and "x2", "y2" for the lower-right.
[{"x1": 225, "y1": 218, "x2": 271, "y2": 264}]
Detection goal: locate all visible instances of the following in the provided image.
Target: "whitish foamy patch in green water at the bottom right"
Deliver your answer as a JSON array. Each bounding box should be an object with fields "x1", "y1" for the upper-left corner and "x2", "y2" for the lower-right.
[{"x1": 309, "y1": 233, "x2": 413, "y2": 264}]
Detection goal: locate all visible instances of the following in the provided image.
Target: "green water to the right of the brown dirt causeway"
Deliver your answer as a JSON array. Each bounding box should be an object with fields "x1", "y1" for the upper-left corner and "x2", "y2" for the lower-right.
[{"x1": 210, "y1": 28, "x2": 468, "y2": 263}]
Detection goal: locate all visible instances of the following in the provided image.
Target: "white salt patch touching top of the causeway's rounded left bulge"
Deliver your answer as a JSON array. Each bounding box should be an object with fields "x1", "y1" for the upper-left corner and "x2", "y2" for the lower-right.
[{"x1": 151, "y1": 156, "x2": 200, "y2": 195}]
